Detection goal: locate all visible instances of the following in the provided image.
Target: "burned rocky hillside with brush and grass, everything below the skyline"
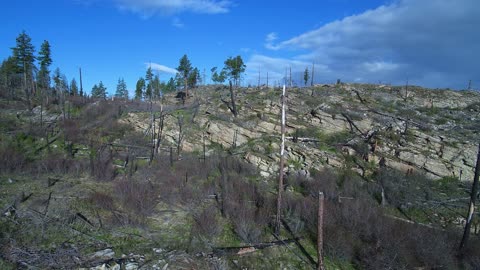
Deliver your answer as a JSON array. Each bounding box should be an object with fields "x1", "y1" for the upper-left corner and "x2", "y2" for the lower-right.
[{"x1": 0, "y1": 84, "x2": 480, "y2": 269}]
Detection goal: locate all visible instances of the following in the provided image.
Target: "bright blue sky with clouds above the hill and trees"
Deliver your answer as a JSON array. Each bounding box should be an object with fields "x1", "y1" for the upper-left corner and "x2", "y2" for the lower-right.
[{"x1": 0, "y1": 0, "x2": 480, "y2": 96}]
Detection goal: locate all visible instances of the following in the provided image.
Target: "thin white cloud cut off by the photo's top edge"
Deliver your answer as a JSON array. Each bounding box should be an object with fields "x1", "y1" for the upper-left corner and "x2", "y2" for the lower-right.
[{"x1": 113, "y1": 0, "x2": 232, "y2": 17}]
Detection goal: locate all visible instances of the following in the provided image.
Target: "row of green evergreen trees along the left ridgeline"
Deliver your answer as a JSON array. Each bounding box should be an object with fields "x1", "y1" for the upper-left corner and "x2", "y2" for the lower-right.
[{"x1": 0, "y1": 31, "x2": 245, "y2": 103}]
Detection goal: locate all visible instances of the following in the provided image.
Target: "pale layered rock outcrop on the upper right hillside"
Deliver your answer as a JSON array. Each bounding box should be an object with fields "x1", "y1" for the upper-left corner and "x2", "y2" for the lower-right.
[{"x1": 124, "y1": 84, "x2": 480, "y2": 181}]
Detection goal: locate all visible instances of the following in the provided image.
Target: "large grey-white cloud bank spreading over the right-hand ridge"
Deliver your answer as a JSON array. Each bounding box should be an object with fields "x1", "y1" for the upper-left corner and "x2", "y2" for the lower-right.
[{"x1": 249, "y1": 0, "x2": 480, "y2": 88}]
